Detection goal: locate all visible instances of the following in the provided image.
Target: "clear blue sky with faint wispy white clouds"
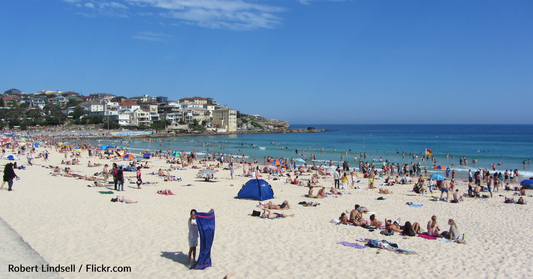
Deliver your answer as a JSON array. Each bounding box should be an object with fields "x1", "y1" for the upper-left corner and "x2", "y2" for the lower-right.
[{"x1": 0, "y1": 0, "x2": 533, "y2": 124}]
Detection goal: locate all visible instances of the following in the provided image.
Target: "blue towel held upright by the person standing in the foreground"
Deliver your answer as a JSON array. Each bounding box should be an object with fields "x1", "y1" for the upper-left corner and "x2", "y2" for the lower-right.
[{"x1": 190, "y1": 211, "x2": 215, "y2": 269}]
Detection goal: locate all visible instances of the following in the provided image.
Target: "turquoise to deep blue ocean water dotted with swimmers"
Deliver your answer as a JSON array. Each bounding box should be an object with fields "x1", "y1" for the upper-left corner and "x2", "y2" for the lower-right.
[{"x1": 94, "y1": 124, "x2": 533, "y2": 178}]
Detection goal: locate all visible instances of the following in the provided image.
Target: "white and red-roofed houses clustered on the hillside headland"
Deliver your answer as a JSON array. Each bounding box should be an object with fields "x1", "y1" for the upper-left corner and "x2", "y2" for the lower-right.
[{"x1": 2, "y1": 89, "x2": 237, "y2": 132}]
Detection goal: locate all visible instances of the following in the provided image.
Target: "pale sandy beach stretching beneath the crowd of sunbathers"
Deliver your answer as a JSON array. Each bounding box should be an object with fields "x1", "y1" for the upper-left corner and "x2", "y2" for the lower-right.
[{"x1": 0, "y1": 147, "x2": 533, "y2": 278}]
